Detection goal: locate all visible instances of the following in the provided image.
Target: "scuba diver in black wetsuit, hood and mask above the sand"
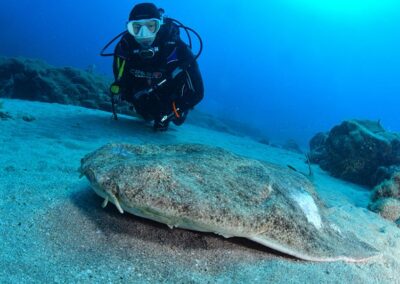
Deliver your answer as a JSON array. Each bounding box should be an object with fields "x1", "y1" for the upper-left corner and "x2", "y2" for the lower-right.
[{"x1": 101, "y1": 3, "x2": 204, "y2": 131}]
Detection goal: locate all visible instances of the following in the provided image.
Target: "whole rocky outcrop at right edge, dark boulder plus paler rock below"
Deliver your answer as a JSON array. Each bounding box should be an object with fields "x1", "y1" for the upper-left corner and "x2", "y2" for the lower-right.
[{"x1": 310, "y1": 120, "x2": 400, "y2": 225}]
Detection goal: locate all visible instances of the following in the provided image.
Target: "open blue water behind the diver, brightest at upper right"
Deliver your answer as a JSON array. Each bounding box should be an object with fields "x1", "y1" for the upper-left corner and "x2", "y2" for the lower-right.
[{"x1": 0, "y1": 0, "x2": 400, "y2": 144}]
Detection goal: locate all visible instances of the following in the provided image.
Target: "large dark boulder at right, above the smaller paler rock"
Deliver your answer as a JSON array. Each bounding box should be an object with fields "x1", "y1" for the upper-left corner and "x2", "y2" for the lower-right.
[{"x1": 310, "y1": 120, "x2": 400, "y2": 186}]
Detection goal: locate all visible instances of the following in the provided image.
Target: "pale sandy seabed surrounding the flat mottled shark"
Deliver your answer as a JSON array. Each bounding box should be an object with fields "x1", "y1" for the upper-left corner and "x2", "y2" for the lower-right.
[{"x1": 0, "y1": 100, "x2": 400, "y2": 284}]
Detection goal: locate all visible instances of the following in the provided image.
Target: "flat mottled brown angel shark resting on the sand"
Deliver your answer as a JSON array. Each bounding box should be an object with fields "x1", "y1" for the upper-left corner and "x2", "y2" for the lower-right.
[{"x1": 80, "y1": 144, "x2": 377, "y2": 262}]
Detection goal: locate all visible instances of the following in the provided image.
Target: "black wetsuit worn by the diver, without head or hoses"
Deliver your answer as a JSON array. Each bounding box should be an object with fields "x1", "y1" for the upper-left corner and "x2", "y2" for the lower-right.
[{"x1": 113, "y1": 20, "x2": 204, "y2": 125}]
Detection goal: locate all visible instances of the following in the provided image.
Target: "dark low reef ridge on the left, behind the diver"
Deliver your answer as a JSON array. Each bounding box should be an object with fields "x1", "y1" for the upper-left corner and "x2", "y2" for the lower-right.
[{"x1": 0, "y1": 57, "x2": 111, "y2": 110}]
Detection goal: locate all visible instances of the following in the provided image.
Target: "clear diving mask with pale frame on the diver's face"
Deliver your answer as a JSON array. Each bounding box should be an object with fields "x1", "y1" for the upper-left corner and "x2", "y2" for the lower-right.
[{"x1": 127, "y1": 18, "x2": 162, "y2": 46}]
